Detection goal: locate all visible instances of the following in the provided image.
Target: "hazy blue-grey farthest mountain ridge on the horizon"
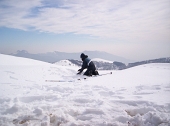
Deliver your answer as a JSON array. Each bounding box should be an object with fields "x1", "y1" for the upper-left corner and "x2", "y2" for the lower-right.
[{"x1": 11, "y1": 50, "x2": 133, "y2": 63}]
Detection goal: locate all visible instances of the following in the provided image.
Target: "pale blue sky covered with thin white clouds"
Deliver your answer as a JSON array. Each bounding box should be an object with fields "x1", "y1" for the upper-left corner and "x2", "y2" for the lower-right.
[{"x1": 0, "y1": 0, "x2": 170, "y2": 60}]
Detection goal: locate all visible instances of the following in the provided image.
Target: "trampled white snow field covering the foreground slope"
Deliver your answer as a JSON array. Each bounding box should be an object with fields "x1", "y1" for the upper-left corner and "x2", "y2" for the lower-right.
[{"x1": 0, "y1": 54, "x2": 170, "y2": 126}]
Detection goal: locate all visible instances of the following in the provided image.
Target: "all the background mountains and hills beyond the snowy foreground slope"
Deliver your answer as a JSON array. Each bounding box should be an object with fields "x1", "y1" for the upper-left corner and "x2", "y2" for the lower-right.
[{"x1": 8, "y1": 50, "x2": 170, "y2": 70}]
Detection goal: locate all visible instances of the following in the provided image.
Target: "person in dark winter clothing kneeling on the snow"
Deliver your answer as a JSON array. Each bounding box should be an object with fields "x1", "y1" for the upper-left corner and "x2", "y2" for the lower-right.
[{"x1": 77, "y1": 53, "x2": 99, "y2": 76}]
